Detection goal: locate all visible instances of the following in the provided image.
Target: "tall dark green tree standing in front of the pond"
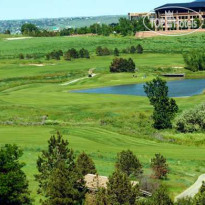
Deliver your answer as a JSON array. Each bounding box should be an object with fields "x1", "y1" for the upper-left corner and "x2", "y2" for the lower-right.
[{"x1": 144, "y1": 77, "x2": 178, "y2": 129}]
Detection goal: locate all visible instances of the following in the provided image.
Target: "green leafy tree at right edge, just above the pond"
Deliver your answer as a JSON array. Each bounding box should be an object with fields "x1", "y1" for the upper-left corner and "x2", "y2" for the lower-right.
[{"x1": 183, "y1": 50, "x2": 205, "y2": 72}]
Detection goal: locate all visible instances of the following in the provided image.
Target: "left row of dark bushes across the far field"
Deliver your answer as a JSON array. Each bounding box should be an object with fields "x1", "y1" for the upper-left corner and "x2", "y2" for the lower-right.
[{"x1": 46, "y1": 48, "x2": 90, "y2": 61}]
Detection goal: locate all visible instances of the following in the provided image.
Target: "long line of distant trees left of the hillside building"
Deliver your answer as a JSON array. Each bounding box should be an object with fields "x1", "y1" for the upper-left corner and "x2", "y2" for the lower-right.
[{"x1": 21, "y1": 18, "x2": 151, "y2": 37}]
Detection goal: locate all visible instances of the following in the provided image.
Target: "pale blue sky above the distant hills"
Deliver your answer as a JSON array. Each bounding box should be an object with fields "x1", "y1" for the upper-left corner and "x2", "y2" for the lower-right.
[{"x1": 0, "y1": 0, "x2": 190, "y2": 20}]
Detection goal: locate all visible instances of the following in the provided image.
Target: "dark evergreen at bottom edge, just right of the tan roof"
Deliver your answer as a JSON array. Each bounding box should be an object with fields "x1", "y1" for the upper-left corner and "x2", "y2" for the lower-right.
[{"x1": 107, "y1": 170, "x2": 139, "y2": 205}]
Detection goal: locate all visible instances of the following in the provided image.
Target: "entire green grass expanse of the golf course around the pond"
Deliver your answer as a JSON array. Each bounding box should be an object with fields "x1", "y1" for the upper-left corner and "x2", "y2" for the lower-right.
[{"x1": 0, "y1": 34, "x2": 205, "y2": 204}]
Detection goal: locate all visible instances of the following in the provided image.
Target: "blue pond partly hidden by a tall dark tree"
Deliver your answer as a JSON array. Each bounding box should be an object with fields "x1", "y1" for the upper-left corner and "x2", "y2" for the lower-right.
[{"x1": 72, "y1": 79, "x2": 205, "y2": 97}]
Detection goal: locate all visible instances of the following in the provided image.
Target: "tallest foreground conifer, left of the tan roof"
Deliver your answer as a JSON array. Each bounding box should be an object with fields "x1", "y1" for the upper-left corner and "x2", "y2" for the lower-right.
[{"x1": 35, "y1": 132, "x2": 85, "y2": 205}]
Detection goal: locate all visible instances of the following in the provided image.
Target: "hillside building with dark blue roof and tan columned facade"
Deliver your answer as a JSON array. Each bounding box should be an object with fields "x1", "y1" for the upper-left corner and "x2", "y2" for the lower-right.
[{"x1": 128, "y1": 0, "x2": 205, "y2": 31}]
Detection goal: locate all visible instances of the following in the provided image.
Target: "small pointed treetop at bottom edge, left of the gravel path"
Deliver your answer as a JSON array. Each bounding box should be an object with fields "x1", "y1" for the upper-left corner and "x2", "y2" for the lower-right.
[{"x1": 148, "y1": 185, "x2": 174, "y2": 205}]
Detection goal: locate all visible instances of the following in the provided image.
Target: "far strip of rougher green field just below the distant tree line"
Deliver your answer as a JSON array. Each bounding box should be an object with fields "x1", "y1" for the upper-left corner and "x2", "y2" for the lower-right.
[{"x1": 0, "y1": 33, "x2": 205, "y2": 58}]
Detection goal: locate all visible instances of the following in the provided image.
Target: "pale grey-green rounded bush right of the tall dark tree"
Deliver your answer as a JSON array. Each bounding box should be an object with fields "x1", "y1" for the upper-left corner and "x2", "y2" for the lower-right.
[{"x1": 175, "y1": 103, "x2": 205, "y2": 132}]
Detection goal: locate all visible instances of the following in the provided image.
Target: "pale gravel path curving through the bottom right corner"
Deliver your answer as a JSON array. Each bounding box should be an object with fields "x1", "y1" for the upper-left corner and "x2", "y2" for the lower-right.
[{"x1": 175, "y1": 174, "x2": 205, "y2": 201}]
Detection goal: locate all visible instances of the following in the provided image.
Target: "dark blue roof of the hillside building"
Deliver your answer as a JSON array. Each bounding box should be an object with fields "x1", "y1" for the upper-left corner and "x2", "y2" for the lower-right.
[{"x1": 155, "y1": 0, "x2": 205, "y2": 10}]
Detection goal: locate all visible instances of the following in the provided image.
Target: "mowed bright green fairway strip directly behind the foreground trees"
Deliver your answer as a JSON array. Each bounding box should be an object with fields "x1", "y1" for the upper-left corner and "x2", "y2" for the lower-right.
[{"x1": 0, "y1": 126, "x2": 205, "y2": 204}]
